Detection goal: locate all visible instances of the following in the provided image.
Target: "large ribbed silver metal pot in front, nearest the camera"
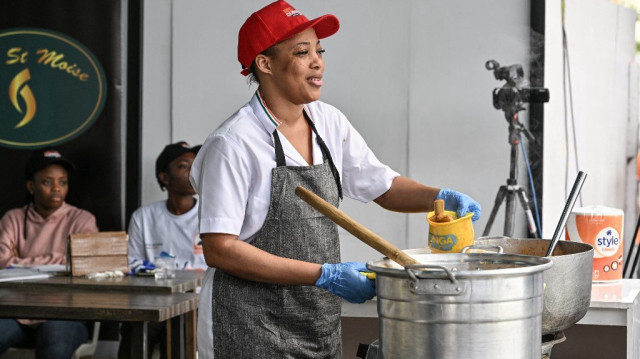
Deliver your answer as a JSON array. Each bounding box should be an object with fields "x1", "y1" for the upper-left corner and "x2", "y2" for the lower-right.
[{"x1": 367, "y1": 252, "x2": 552, "y2": 359}]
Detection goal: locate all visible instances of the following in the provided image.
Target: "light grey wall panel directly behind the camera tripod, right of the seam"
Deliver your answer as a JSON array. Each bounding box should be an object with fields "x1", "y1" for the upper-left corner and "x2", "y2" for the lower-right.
[{"x1": 408, "y1": 0, "x2": 530, "y2": 248}]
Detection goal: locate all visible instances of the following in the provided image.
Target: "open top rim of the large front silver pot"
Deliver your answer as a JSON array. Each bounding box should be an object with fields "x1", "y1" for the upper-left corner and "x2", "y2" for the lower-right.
[{"x1": 367, "y1": 250, "x2": 552, "y2": 279}]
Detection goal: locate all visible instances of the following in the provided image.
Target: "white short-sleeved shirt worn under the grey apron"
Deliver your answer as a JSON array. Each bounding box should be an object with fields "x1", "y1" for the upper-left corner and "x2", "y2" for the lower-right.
[{"x1": 190, "y1": 90, "x2": 399, "y2": 242}]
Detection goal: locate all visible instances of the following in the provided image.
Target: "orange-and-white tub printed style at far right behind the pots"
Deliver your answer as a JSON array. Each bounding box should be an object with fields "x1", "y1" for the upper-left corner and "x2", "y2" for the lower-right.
[{"x1": 566, "y1": 207, "x2": 624, "y2": 281}]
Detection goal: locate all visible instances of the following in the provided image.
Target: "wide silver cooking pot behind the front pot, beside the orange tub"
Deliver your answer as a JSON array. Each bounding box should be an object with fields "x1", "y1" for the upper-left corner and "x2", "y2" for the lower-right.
[{"x1": 474, "y1": 237, "x2": 593, "y2": 334}]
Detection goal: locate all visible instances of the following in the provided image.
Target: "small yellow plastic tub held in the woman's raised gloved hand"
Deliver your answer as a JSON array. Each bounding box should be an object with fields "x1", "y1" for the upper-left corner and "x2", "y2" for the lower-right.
[{"x1": 427, "y1": 211, "x2": 475, "y2": 253}]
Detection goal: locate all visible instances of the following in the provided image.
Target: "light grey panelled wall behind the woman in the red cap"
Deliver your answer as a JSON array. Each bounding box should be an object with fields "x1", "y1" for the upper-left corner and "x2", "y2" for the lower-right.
[{"x1": 172, "y1": 0, "x2": 529, "y2": 260}]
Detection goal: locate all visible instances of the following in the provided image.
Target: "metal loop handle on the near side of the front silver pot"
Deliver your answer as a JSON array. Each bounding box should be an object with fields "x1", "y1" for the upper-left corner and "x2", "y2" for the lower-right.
[{"x1": 405, "y1": 264, "x2": 467, "y2": 295}]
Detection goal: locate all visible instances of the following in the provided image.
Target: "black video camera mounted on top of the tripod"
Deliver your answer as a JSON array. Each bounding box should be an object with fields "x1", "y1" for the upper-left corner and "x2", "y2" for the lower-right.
[{"x1": 484, "y1": 60, "x2": 549, "y2": 115}]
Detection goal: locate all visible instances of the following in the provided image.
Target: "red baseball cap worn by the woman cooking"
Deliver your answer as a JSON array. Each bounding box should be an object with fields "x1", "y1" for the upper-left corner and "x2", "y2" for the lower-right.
[{"x1": 238, "y1": 0, "x2": 340, "y2": 76}]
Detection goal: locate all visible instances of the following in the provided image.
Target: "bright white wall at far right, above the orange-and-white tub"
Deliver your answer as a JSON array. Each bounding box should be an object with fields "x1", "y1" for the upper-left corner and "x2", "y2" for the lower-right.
[{"x1": 543, "y1": 0, "x2": 638, "y2": 242}]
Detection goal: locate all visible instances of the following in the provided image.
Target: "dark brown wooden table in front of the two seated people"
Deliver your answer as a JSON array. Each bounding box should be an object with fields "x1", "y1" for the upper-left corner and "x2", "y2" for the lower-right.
[{"x1": 0, "y1": 271, "x2": 204, "y2": 359}]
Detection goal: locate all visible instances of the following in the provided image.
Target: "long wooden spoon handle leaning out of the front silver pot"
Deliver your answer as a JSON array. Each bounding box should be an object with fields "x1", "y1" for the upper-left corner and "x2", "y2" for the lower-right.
[{"x1": 296, "y1": 186, "x2": 420, "y2": 267}]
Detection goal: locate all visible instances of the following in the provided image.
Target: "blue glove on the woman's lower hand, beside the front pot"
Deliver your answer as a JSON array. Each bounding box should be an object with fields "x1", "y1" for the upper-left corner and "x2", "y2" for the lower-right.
[{"x1": 316, "y1": 262, "x2": 376, "y2": 303}]
